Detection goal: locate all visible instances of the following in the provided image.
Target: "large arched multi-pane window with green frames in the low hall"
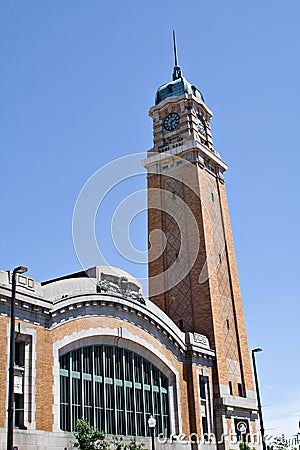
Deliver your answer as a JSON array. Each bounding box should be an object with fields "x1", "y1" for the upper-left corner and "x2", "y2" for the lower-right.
[{"x1": 59, "y1": 345, "x2": 170, "y2": 436}]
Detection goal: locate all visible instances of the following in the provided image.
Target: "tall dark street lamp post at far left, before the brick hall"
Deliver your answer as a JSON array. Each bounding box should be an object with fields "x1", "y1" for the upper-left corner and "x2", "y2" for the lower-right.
[{"x1": 7, "y1": 266, "x2": 28, "y2": 450}]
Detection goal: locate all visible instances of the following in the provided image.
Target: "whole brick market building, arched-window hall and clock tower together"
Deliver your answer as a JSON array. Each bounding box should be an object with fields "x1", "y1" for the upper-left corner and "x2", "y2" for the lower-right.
[{"x1": 0, "y1": 43, "x2": 259, "y2": 450}]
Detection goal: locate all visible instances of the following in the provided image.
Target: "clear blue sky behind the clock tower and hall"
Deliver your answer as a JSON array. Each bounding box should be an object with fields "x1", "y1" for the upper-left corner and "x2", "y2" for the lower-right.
[{"x1": 0, "y1": 0, "x2": 300, "y2": 435}]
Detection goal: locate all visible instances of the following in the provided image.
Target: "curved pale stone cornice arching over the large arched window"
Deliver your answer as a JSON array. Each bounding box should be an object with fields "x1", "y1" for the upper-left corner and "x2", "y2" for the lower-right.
[{"x1": 0, "y1": 280, "x2": 215, "y2": 363}]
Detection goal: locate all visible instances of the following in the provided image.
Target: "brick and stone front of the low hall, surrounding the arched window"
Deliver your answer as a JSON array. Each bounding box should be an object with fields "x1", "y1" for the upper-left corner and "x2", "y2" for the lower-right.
[{"x1": 0, "y1": 268, "x2": 214, "y2": 450}]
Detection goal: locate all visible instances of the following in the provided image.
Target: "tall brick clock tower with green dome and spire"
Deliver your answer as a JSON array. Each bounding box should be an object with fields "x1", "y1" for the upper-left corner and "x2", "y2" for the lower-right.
[{"x1": 143, "y1": 38, "x2": 257, "y2": 447}]
